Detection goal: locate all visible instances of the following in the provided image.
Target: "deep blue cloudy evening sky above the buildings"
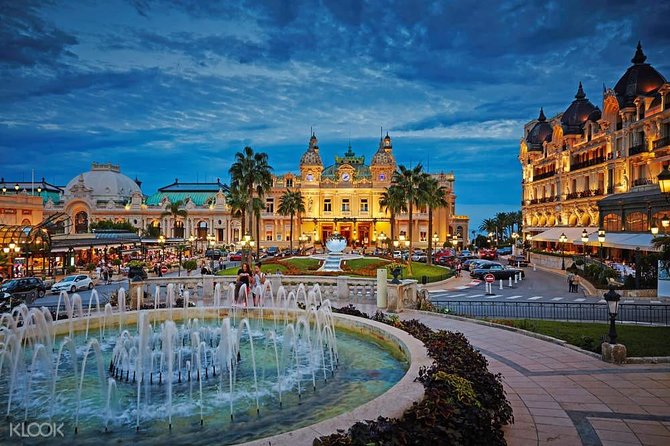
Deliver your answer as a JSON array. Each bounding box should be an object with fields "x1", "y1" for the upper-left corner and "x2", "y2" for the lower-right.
[{"x1": 0, "y1": 0, "x2": 670, "y2": 230}]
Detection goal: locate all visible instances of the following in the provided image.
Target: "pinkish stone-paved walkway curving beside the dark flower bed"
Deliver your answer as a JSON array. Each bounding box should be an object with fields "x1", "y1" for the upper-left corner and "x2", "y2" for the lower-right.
[{"x1": 354, "y1": 306, "x2": 670, "y2": 446}]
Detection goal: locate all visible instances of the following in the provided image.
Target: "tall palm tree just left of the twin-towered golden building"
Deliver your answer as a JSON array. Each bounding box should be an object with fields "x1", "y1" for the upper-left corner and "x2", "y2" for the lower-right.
[{"x1": 230, "y1": 146, "x2": 272, "y2": 240}]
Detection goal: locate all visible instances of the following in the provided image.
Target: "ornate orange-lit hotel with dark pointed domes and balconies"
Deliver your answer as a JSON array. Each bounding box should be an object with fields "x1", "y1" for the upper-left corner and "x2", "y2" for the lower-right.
[{"x1": 519, "y1": 43, "x2": 670, "y2": 253}]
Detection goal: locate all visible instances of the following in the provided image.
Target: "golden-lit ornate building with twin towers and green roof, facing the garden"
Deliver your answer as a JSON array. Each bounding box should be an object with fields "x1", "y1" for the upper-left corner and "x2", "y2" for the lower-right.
[{"x1": 260, "y1": 134, "x2": 469, "y2": 251}]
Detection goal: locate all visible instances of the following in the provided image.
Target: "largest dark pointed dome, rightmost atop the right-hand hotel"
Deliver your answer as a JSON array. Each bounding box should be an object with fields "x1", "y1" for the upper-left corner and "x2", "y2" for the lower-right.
[{"x1": 614, "y1": 42, "x2": 667, "y2": 108}]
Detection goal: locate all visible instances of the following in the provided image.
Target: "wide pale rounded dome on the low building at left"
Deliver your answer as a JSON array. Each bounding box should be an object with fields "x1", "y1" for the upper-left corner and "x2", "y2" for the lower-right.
[{"x1": 65, "y1": 163, "x2": 142, "y2": 201}]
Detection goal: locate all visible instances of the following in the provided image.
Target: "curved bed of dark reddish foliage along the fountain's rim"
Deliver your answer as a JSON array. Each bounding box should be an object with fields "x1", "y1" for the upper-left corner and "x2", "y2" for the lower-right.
[{"x1": 314, "y1": 305, "x2": 513, "y2": 446}]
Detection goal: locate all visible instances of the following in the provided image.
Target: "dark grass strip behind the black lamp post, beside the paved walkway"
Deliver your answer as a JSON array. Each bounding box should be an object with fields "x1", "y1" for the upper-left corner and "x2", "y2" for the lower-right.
[{"x1": 492, "y1": 319, "x2": 670, "y2": 357}]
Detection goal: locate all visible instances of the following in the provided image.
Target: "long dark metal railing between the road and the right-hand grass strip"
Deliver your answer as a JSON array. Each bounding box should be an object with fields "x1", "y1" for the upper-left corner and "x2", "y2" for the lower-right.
[{"x1": 431, "y1": 300, "x2": 670, "y2": 325}]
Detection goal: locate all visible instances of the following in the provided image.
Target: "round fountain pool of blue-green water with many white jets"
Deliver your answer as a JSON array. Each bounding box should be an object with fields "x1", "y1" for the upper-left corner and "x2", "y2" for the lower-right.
[{"x1": 0, "y1": 278, "x2": 408, "y2": 444}]
